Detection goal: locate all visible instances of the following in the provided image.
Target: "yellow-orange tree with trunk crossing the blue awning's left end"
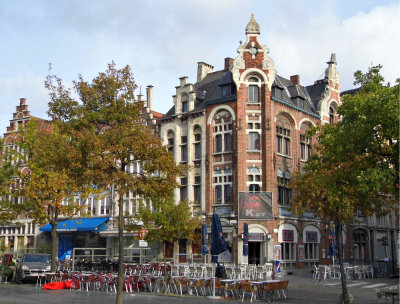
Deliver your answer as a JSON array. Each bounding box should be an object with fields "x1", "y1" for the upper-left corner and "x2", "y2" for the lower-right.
[{"x1": 18, "y1": 118, "x2": 96, "y2": 272}]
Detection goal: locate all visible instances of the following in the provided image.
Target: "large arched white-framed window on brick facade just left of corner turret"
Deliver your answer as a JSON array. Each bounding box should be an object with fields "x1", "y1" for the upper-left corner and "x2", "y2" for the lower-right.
[{"x1": 213, "y1": 111, "x2": 232, "y2": 152}]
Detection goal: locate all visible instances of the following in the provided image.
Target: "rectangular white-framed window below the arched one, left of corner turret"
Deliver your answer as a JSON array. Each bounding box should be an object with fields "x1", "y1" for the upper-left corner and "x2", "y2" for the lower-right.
[{"x1": 213, "y1": 169, "x2": 232, "y2": 204}]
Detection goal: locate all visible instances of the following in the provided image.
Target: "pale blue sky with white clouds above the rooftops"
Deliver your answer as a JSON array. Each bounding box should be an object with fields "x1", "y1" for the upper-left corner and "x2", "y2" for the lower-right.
[{"x1": 0, "y1": 0, "x2": 400, "y2": 134}]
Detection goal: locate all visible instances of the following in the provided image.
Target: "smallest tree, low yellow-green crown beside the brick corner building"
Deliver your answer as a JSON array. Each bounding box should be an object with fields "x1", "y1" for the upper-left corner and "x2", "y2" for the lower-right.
[{"x1": 137, "y1": 199, "x2": 200, "y2": 276}]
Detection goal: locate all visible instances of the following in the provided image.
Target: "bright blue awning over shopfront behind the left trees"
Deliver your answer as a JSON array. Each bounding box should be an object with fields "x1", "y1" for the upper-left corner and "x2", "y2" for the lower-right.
[{"x1": 40, "y1": 217, "x2": 109, "y2": 232}]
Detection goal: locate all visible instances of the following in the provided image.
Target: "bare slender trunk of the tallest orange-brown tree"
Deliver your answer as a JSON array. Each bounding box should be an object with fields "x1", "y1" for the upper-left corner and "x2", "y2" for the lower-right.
[{"x1": 116, "y1": 193, "x2": 124, "y2": 304}]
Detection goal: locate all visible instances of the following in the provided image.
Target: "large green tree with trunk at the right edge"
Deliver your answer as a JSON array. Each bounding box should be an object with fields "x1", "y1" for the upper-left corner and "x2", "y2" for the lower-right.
[{"x1": 291, "y1": 66, "x2": 399, "y2": 303}]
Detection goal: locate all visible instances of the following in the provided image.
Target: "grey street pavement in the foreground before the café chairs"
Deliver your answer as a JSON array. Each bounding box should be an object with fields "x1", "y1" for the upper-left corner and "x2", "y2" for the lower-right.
[{"x1": 0, "y1": 274, "x2": 399, "y2": 304}]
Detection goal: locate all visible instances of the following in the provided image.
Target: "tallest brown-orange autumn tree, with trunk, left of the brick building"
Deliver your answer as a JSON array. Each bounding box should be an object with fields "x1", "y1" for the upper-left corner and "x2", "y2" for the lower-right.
[{"x1": 46, "y1": 63, "x2": 181, "y2": 303}]
